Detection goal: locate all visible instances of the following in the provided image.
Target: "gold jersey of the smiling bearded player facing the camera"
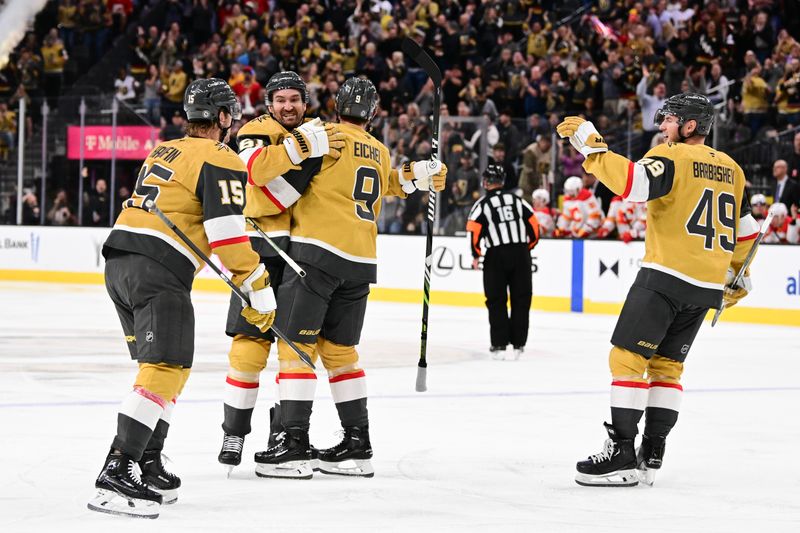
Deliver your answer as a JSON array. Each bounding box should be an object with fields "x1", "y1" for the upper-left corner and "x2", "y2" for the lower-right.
[{"x1": 236, "y1": 115, "x2": 322, "y2": 257}]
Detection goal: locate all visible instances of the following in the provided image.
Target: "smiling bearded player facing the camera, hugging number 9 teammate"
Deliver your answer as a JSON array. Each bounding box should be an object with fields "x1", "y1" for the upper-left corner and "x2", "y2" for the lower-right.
[{"x1": 218, "y1": 72, "x2": 344, "y2": 468}]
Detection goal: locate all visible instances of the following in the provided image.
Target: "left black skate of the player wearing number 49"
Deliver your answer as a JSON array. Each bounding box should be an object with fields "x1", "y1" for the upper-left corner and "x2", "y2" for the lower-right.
[{"x1": 575, "y1": 423, "x2": 639, "y2": 487}]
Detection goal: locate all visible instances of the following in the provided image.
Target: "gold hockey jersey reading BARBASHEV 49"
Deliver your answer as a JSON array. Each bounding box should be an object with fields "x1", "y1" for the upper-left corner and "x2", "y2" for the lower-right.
[{"x1": 583, "y1": 143, "x2": 759, "y2": 308}]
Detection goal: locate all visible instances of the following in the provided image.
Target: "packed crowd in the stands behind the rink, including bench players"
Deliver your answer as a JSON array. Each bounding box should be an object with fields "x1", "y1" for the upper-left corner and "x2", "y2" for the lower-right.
[{"x1": 0, "y1": 0, "x2": 800, "y2": 242}]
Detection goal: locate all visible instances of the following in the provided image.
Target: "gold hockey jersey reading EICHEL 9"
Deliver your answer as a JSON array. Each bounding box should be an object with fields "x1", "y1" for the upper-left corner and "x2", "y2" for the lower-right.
[{"x1": 290, "y1": 123, "x2": 406, "y2": 283}]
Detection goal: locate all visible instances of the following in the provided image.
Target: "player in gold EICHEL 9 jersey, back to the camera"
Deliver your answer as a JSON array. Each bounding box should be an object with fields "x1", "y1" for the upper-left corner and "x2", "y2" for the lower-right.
[{"x1": 255, "y1": 78, "x2": 447, "y2": 479}]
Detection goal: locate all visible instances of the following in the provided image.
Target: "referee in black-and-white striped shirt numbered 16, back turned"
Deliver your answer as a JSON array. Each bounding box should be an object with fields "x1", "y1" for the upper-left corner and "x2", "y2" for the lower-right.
[{"x1": 467, "y1": 165, "x2": 539, "y2": 361}]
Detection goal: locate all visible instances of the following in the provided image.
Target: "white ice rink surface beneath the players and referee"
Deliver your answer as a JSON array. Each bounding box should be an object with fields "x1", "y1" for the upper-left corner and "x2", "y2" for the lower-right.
[{"x1": 0, "y1": 282, "x2": 800, "y2": 533}]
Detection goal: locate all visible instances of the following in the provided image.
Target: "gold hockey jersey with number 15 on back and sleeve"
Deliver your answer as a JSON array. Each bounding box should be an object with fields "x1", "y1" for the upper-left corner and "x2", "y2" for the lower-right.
[{"x1": 103, "y1": 137, "x2": 259, "y2": 288}]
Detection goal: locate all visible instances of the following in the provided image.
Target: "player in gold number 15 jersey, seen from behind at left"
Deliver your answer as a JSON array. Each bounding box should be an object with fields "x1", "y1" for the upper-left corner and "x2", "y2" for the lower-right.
[{"x1": 88, "y1": 79, "x2": 275, "y2": 518}]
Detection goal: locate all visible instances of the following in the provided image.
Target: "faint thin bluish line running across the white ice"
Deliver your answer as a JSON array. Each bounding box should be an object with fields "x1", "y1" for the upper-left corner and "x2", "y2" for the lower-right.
[{"x1": 0, "y1": 387, "x2": 800, "y2": 409}]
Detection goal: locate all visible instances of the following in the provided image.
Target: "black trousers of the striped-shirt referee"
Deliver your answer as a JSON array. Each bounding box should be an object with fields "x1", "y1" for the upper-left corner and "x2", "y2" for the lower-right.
[{"x1": 483, "y1": 244, "x2": 533, "y2": 347}]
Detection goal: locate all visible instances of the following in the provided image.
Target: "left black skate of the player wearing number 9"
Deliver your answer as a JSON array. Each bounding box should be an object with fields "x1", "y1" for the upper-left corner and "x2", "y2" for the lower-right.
[{"x1": 255, "y1": 428, "x2": 314, "y2": 479}]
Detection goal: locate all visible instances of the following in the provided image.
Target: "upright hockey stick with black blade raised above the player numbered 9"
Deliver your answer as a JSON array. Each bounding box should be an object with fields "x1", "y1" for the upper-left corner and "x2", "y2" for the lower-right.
[{"x1": 401, "y1": 37, "x2": 442, "y2": 392}]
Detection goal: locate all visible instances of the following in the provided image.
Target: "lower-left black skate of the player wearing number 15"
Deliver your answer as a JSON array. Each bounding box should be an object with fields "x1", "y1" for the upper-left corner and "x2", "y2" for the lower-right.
[{"x1": 87, "y1": 453, "x2": 163, "y2": 518}]
